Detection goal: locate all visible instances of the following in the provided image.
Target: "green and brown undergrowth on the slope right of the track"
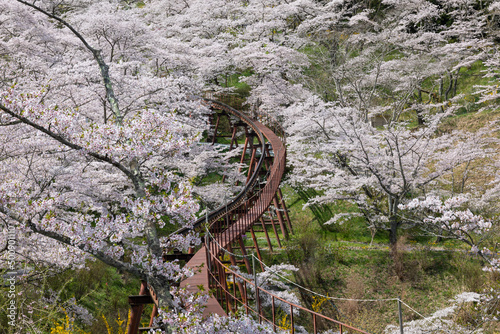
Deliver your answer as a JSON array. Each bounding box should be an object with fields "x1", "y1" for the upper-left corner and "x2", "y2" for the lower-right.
[{"x1": 265, "y1": 188, "x2": 498, "y2": 333}]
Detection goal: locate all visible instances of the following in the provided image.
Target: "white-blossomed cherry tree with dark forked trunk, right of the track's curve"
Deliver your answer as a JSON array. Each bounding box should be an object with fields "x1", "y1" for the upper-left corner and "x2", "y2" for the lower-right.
[{"x1": 288, "y1": 96, "x2": 491, "y2": 243}]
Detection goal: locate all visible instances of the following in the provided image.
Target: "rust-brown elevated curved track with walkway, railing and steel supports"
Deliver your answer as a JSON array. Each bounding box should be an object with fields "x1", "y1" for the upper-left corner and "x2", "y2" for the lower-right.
[{"x1": 128, "y1": 96, "x2": 368, "y2": 334}]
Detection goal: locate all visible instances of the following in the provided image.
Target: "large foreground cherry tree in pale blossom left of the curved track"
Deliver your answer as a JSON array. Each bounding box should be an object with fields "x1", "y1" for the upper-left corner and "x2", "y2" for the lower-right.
[{"x1": 0, "y1": 1, "x2": 223, "y2": 332}]
